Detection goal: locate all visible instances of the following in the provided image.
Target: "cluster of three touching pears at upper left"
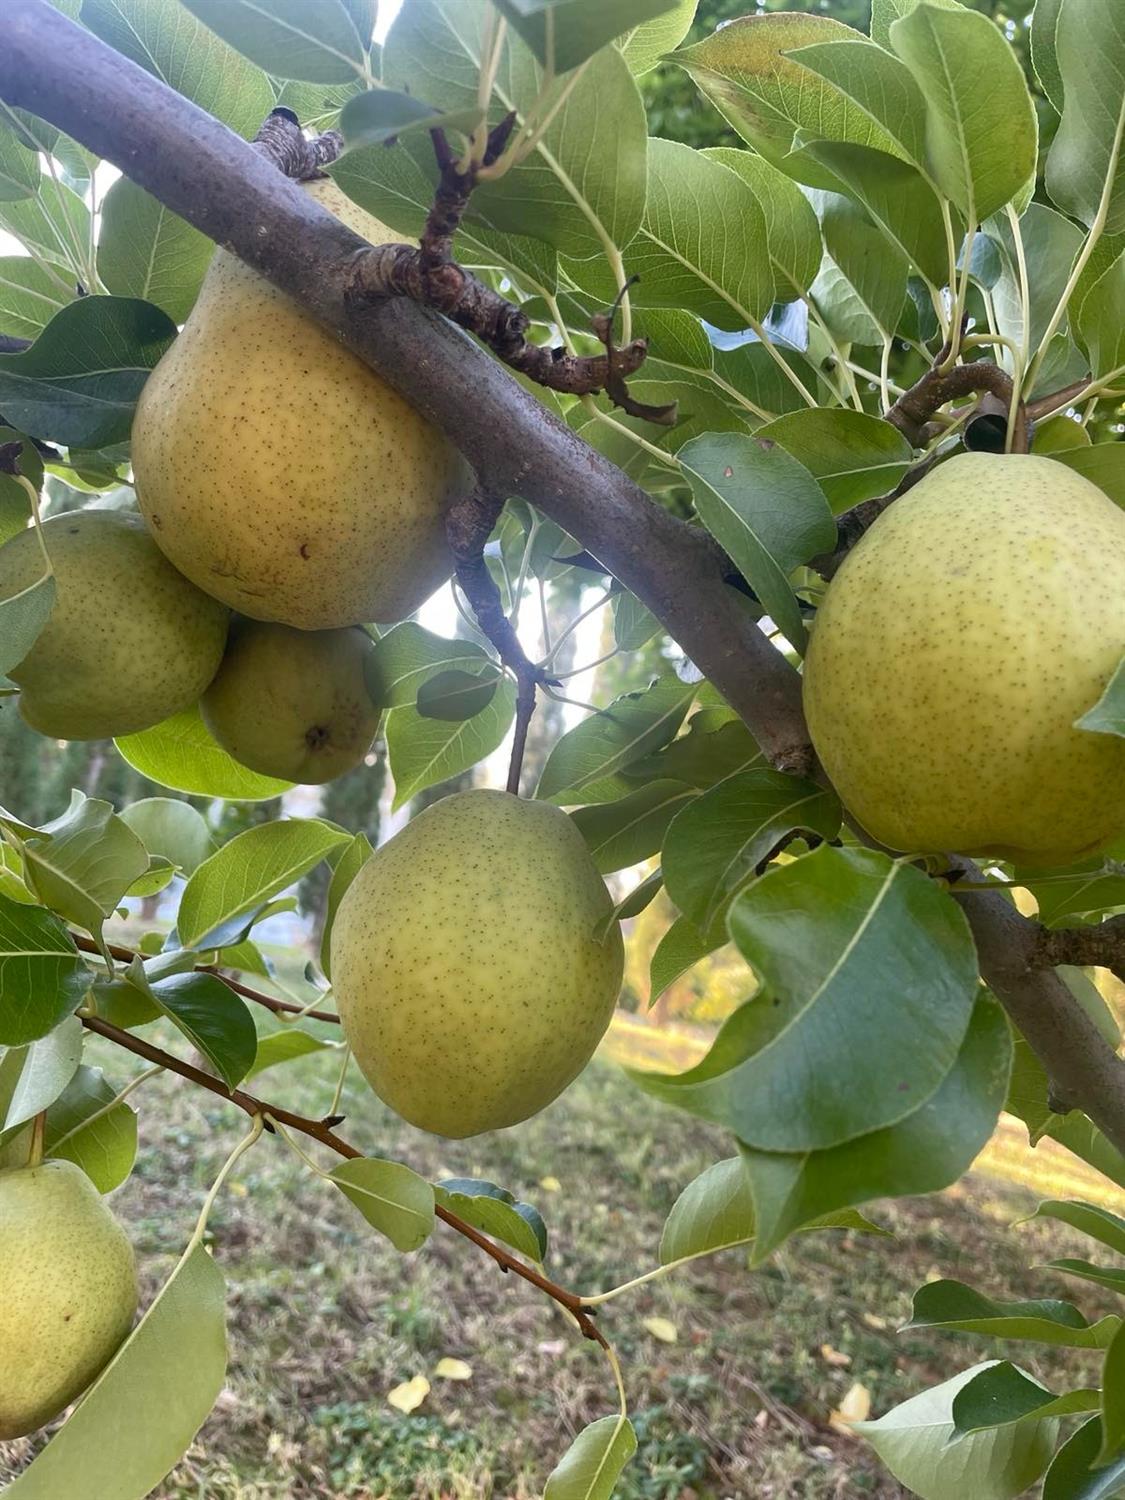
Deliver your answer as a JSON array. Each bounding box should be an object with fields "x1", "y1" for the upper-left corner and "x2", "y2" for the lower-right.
[{"x1": 0, "y1": 180, "x2": 461, "y2": 782}]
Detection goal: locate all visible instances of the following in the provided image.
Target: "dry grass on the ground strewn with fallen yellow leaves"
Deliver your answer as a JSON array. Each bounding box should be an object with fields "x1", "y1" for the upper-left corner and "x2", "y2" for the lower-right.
[{"x1": 0, "y1": 1026, "x2": 1107, "y2": 1500}]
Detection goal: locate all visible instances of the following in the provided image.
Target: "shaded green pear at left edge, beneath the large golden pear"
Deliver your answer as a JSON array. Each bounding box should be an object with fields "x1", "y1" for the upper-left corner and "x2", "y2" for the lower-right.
[{"x1": 0, "y1": 510, "x2": 228, "y2": 740}]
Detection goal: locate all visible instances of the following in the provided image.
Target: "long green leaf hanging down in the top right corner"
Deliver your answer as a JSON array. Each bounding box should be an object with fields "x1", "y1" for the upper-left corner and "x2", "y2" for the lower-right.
[{"x1": 1046, "y1": 0, "x2": 1125, "y2": 234}]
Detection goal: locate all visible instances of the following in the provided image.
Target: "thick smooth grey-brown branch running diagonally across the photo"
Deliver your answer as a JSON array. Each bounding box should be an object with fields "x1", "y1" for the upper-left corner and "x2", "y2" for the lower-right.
[{"x1": 0, "y1": 0, "x2": 1125, "y2": 1151}]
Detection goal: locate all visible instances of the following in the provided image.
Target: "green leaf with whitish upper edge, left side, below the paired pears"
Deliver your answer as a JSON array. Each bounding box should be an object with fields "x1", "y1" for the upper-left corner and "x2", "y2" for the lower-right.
[{"x1": 23, "y1": 792, "x2": 149, "y2": 936}]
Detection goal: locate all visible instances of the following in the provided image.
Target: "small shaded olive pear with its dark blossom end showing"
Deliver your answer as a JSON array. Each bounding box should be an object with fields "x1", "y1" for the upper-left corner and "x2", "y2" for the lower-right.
[{"x1": 207, "y1": 620, "x2": 380, "y2": 783}]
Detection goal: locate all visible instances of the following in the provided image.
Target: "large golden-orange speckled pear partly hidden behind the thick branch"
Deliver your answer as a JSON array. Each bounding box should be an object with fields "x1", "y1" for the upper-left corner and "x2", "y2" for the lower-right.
[{"x1": 132, "y1": 180, "x2": 462, "y2": 630}]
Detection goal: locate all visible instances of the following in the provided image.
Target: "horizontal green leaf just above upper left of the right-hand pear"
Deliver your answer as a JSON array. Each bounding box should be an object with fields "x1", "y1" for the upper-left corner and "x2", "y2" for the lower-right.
[{"x1": 755, "y1": 407, "x2": 912, "y2": 515}]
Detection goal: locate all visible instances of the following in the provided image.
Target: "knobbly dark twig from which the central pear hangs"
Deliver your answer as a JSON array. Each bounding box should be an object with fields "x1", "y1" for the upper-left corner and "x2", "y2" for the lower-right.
[{"x1": 446, "y1": 491, "x2": 557, "y2": 797}]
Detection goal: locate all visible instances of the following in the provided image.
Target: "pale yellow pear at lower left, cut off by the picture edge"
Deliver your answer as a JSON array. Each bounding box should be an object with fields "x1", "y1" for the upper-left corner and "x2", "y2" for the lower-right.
[{"x1": 0, "y1": 1161, "x2": 137, "y2": 1440}]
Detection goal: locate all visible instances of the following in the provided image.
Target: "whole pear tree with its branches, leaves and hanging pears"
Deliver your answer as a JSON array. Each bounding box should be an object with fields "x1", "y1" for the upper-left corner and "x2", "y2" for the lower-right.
[{"x1": 0, "y1": 0, "x2": 1125, "y2": 1500}]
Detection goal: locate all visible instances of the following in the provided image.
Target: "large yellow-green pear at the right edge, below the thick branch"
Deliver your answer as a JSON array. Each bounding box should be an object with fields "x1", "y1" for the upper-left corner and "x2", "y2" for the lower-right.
[{"x1": 804, "y1": 453, "x2": 1125, "y2": 866}]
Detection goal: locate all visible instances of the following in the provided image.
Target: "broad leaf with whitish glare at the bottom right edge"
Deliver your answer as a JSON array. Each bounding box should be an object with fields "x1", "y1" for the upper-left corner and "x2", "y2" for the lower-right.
[{"x1": 852, "y1": 1362, "x2": 1059, "y2": 1500}]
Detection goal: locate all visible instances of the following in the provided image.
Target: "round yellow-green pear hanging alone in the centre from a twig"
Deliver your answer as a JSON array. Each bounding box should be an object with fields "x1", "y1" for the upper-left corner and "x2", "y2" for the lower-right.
[{"x1": 332, "y1": 791, "x2": 624, "y2": 1137}]
